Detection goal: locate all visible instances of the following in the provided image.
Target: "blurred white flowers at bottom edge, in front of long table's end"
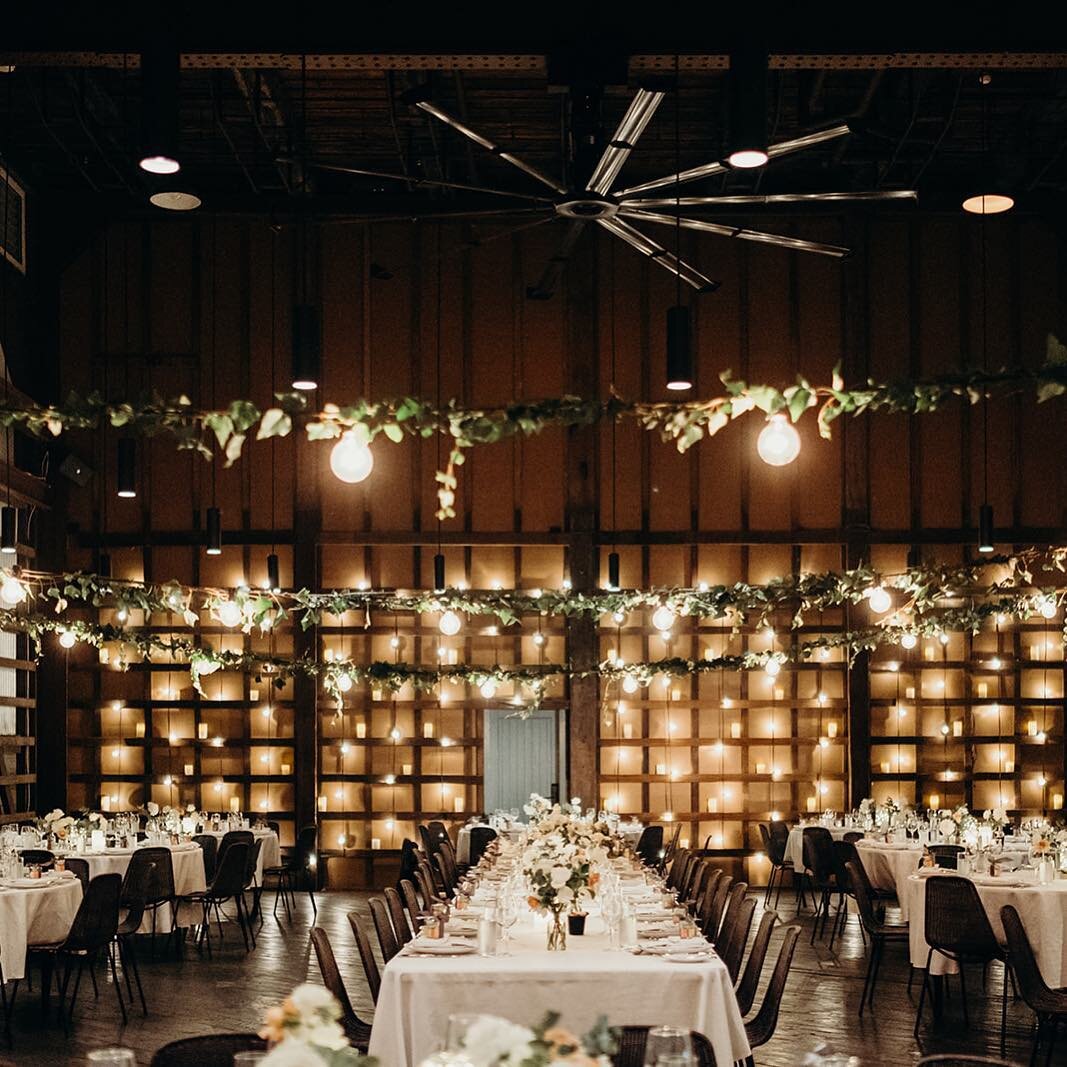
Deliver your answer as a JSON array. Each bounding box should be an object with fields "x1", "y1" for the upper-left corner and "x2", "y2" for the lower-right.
[{"x1": 435, "y1": 1012, "x2": 616, "y2": 1067}]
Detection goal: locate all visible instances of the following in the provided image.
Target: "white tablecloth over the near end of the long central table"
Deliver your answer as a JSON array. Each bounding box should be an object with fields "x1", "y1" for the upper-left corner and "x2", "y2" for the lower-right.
[{"x1": 370, "y1": 914, "x2": 750, "y2": 1067}]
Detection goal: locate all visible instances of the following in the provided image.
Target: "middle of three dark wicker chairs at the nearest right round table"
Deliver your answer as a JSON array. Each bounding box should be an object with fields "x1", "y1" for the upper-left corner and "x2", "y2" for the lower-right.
[{"x1": 914, "y1": 875, "x2": 1009, "y2": 1042}]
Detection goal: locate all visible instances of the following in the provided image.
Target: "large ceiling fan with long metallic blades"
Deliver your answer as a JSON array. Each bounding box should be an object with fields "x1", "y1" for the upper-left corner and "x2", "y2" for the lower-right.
[{"x1": 317, "y1": 89, "x2": 917, "y2": 300}]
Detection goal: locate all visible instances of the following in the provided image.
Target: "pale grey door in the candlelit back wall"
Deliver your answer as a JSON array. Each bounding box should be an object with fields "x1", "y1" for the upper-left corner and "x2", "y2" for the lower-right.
[{"x1": 484, "y1": 710, "x2": 559, "y2": 813}]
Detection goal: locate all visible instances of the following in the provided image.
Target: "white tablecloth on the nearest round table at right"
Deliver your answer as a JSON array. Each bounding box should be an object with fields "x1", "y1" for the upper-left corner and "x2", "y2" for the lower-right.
[{"x1": 902, "y1": 871, "x2": 1067, "y2": 989}]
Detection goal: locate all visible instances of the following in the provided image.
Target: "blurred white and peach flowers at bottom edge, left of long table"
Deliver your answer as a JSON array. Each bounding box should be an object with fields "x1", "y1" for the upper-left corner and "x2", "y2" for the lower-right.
[{"x1": 259, "y1": 985, "x2": 378, "y2": 1067}]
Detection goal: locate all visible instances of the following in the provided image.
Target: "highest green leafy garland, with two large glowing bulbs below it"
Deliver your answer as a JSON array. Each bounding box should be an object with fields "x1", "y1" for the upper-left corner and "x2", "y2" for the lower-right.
[{"x1": 10, "y1": 335, "x2": 1067, "y2": 519}]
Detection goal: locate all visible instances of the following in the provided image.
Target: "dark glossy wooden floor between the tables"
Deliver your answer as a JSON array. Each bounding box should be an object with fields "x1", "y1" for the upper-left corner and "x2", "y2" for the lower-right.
[{"x1": 0, "y1": 891, "x2": 1054, "y2": 1067}]
